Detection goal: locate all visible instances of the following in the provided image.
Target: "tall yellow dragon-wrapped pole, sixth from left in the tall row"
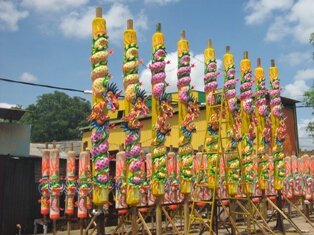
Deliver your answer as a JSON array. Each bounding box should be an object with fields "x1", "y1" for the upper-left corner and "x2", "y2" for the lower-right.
[{"x1": 223, "y1": 46, "x2": 241, "y2": 197}]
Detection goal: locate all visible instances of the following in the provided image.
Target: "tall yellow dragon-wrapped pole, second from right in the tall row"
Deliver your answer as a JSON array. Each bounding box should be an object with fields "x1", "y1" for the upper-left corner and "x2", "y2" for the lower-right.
[{"x1": 254, "y1": 58, "x2": 271, "y2": 191}]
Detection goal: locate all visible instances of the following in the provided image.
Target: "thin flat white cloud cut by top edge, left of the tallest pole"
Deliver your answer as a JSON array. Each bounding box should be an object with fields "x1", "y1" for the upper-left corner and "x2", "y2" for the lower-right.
[{"x1": 22, "y1": 0, "x2": 89, "y2": 12}]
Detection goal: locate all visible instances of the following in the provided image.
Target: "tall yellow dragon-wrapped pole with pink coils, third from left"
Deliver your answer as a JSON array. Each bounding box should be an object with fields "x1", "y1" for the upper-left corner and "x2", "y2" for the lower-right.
[{"x1": 149, "y1": 23, "x2": 173, "y2": 196}]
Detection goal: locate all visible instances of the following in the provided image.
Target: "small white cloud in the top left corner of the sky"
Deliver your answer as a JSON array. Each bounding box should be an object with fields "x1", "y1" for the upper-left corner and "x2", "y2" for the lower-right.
[{"x1": 0, "y1": 1, "x2": 28, "y2": 31}]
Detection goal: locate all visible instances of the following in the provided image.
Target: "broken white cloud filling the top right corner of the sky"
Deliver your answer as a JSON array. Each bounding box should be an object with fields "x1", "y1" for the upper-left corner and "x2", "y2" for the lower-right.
[{"x1": 245, "y1": 0, "x2": 314, "y2": 43}]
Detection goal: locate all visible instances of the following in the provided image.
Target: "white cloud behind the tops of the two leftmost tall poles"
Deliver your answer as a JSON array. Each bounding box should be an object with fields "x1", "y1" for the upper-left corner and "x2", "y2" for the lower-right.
[{"x1": 60, "y1": 3, "x2": 147, "y2": 43}]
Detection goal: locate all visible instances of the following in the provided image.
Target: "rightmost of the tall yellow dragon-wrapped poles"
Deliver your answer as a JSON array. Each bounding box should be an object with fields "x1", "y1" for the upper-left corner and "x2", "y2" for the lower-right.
[{"x1": 269, "y1": 60, "x2": 286, "y2": 191}]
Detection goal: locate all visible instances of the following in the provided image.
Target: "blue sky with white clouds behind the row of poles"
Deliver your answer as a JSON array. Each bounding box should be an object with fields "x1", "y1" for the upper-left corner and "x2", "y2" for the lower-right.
[{"x1": 0, "y1": 0, "x2": 314, "y2": 149}]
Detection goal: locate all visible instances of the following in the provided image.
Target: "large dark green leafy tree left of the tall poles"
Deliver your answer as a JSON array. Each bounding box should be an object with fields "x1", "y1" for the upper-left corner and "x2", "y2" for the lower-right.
[{"x1": 21, "y1": 91, "x2": 91, "y2": 142}]
